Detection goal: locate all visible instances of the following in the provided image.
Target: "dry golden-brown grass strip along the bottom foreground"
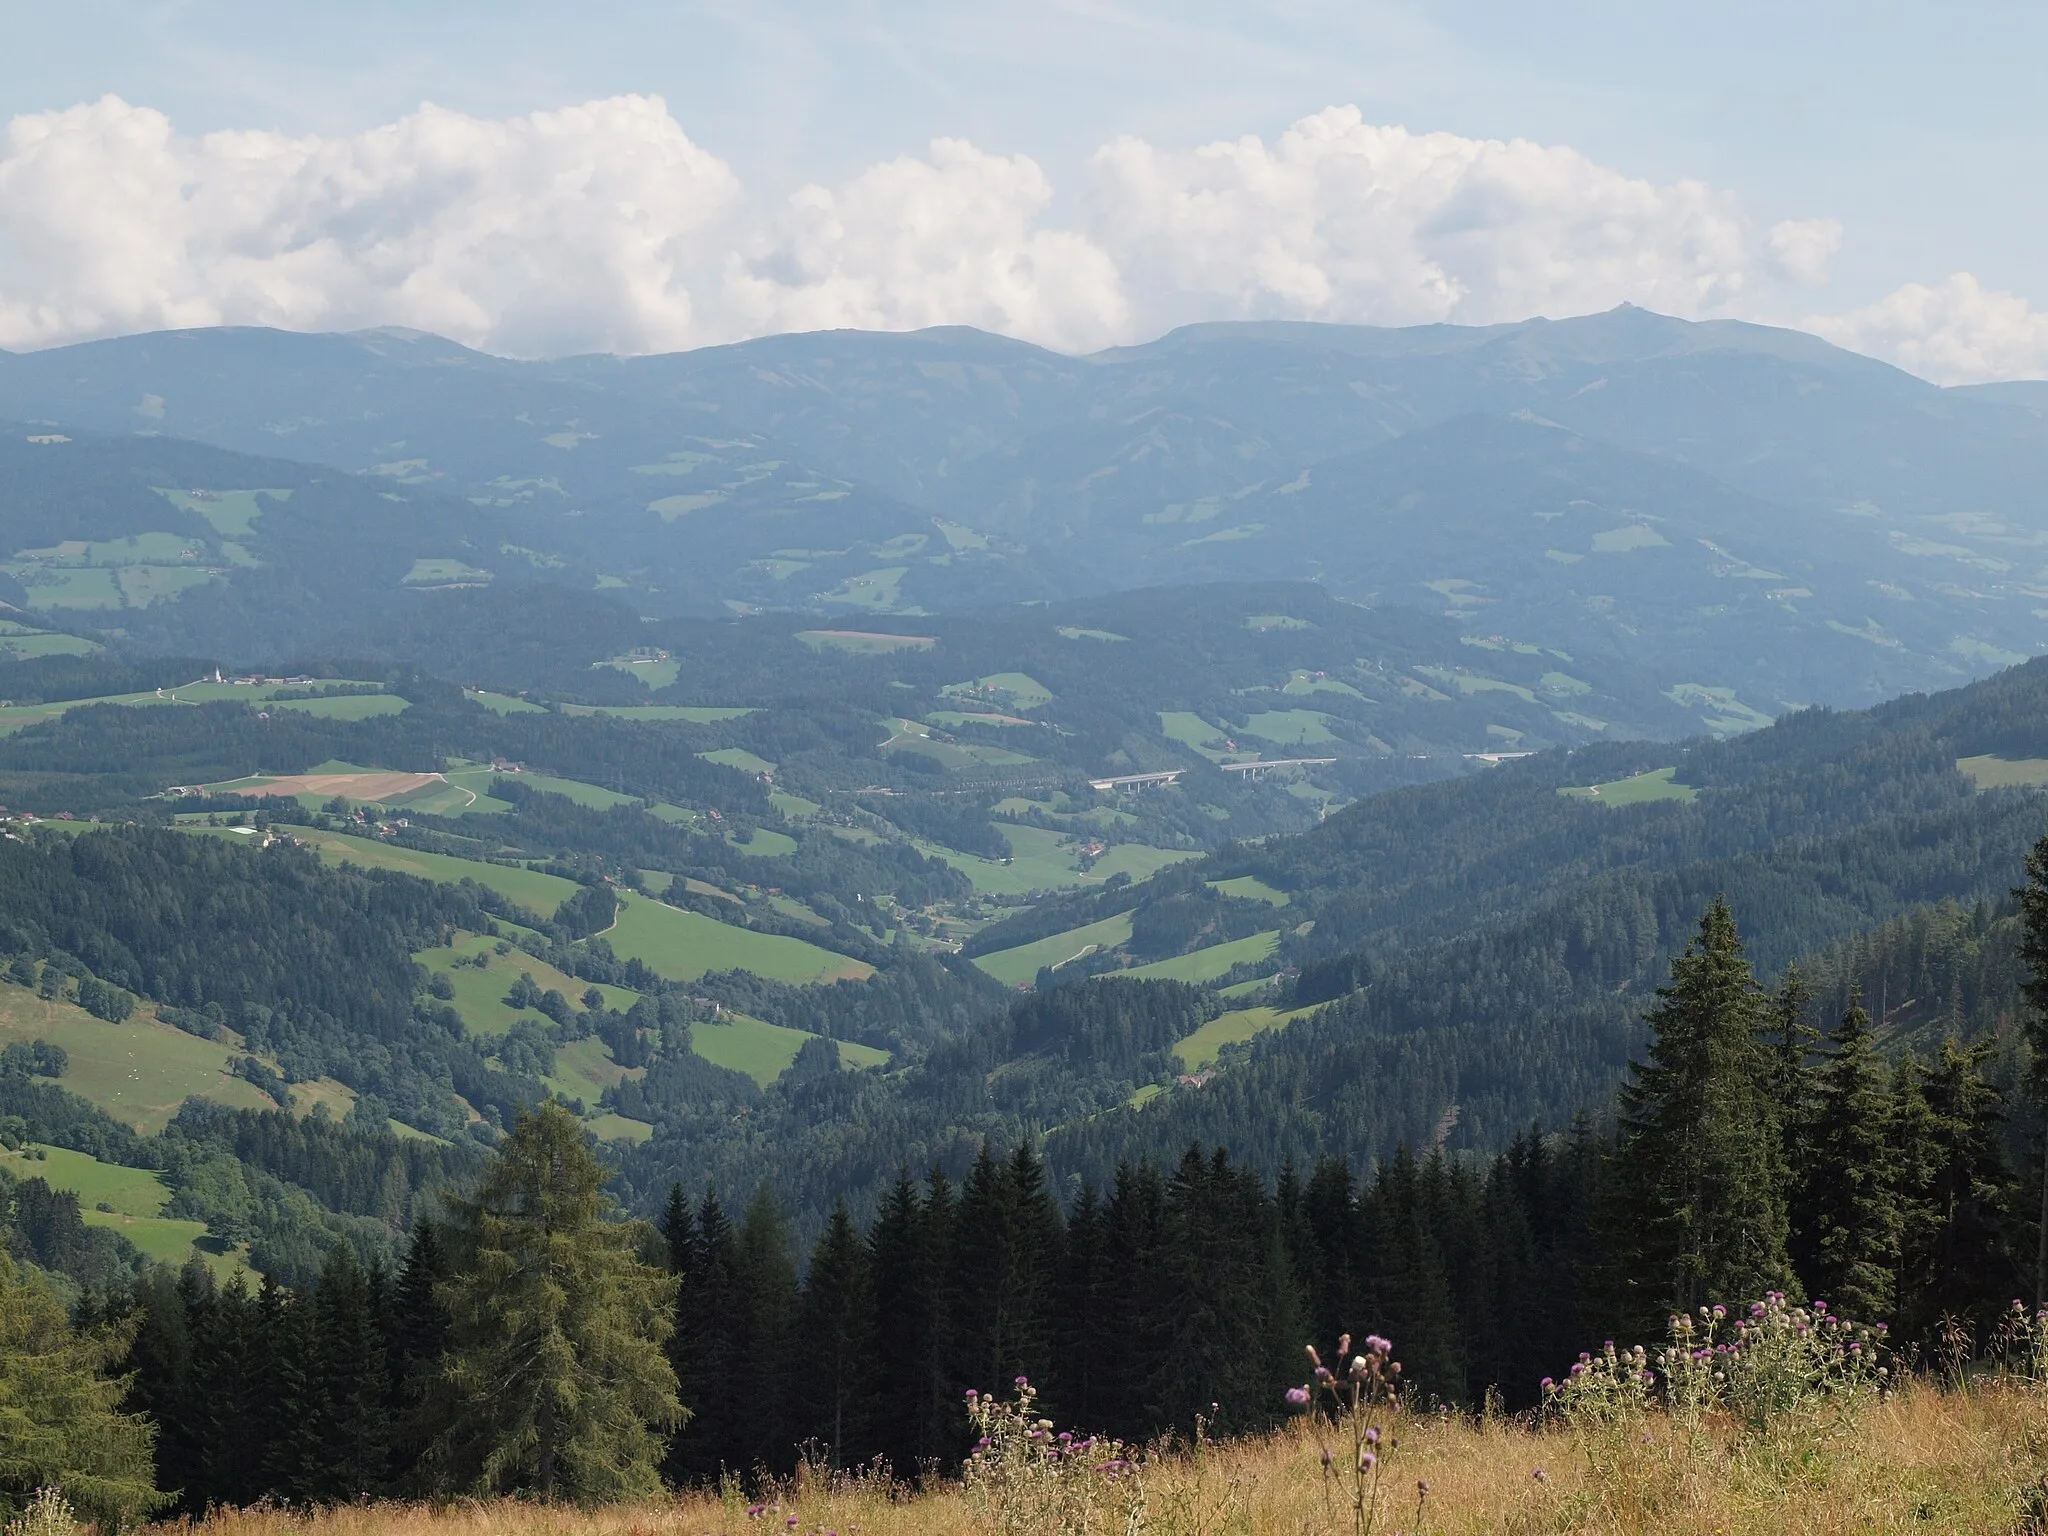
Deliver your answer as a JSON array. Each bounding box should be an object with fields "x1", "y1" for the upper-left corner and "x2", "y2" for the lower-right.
[{"x1": 155, "y1": 1384, "x2": 2048, "y2": 1536}]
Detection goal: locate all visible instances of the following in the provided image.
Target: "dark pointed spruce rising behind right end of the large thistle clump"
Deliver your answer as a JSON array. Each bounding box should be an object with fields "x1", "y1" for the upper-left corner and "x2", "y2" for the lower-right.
[{"x1": 1792, "y1": 1008, "x2": 1901, "y2": 1321}]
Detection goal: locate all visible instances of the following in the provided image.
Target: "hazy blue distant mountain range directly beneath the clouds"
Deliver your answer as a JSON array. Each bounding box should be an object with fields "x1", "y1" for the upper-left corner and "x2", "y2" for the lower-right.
[{"x1": 0, "y1": 307, "x2": 2048, "y2": 729}]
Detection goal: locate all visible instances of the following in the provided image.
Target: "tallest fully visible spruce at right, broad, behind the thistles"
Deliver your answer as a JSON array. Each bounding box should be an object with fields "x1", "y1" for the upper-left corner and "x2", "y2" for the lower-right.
[{"x1": 1608, "y1": 899, "x2": 1794, "y2": 1337}]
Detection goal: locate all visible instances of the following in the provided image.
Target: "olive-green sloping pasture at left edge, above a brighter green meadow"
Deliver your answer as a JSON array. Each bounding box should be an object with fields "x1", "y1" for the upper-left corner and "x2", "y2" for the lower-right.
[{"x1": 0, "y1": 985, "x2": 276, "y2": 1135}]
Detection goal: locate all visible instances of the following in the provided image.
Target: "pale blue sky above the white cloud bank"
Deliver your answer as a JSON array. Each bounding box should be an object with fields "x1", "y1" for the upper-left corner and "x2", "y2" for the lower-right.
[{"x1": 0, "y1": 0, "x2": 2048, "y2": 376}]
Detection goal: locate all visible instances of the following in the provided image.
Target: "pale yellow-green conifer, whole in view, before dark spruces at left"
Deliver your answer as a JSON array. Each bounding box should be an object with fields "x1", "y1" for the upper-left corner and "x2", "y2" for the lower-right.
[{"x1": 432, "y1": 1102, "x2": 684, "y2": 1501}]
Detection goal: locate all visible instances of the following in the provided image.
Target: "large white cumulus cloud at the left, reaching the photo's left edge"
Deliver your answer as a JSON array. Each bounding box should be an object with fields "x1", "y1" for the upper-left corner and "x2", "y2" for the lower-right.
[{"x1": 0, "y1": 96, "x2": 739, "y2": 352}]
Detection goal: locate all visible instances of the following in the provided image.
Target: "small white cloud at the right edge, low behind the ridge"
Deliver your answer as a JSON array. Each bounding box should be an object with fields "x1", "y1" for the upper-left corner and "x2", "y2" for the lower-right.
[{"x1": 1804, "y1": 272, "x2": 2048, "y2": 383}]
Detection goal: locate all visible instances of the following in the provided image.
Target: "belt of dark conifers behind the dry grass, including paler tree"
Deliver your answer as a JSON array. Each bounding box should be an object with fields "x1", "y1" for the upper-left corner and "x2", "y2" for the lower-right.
[{"x1": 0, "y1": 876, "x2": 2023, "y2": 1513}]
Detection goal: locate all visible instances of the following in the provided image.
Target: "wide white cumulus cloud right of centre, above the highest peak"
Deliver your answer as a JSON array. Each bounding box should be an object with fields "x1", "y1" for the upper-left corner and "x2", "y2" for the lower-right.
[{"x1": 1090, "y1": 106, "x2": 1755, "y2": 326}]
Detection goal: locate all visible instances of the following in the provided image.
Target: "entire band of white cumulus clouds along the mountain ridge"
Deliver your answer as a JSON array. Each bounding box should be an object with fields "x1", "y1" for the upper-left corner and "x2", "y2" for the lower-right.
[{"x1": 0, "y1": 96, "x2": 2048, "y2": 381}]
